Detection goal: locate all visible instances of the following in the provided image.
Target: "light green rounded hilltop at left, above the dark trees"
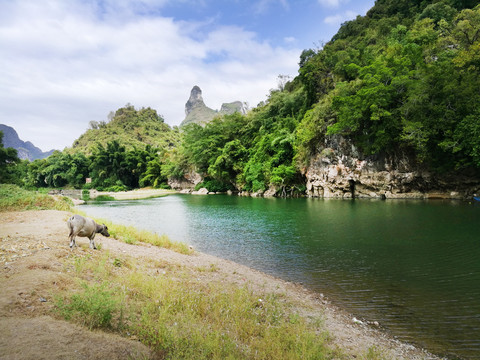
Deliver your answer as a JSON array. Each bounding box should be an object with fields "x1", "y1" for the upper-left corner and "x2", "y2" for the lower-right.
[{"x1": 67, "y1": 104, "x2": 179, "y2": 154}]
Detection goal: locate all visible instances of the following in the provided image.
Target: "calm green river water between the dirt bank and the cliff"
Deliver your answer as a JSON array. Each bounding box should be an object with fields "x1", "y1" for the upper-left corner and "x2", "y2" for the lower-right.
[{"x1": 81, "y1": 195, "x2": 480, "y2": 359}]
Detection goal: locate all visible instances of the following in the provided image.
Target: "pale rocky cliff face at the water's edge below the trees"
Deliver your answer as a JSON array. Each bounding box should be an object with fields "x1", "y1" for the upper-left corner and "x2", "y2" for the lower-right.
[{"x1": 305, "y1": 137, "x2": 480, "y2": 199}]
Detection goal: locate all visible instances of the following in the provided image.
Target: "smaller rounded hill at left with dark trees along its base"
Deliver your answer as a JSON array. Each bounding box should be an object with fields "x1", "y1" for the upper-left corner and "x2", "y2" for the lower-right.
[{"x1": 16, "y1": 105, "x2": 180, "y2": 191}]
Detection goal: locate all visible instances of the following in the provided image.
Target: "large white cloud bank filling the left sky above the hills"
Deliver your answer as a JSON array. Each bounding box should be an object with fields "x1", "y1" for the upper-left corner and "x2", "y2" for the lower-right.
[{"x1": 0, "y1": 0, "x2": 300, "y2": 150}]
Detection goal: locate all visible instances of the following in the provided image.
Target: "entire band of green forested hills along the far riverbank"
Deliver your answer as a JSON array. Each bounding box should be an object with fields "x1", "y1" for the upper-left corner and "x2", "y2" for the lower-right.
[{"x1": 3, "y1": 0, "x2": 480, "y2": 195}]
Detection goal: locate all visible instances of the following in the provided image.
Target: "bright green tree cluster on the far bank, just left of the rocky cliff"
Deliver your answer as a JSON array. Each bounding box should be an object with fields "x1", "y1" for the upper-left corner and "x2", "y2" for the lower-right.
[{"x1": 181, "y1": 89, "x2": 306, "y2": 191}]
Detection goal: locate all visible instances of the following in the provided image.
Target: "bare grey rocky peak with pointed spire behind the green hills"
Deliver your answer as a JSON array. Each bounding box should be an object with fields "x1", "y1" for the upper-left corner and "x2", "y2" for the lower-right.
[{"x1": 180, "y1": 85, "x2": 248, "y2": 126}]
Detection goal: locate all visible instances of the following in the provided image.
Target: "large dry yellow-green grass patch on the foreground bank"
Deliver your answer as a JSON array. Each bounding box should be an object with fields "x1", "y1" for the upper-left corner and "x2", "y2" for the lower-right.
[{"x1": 56, "y1": 253, "x2": 342, "y2": 359}]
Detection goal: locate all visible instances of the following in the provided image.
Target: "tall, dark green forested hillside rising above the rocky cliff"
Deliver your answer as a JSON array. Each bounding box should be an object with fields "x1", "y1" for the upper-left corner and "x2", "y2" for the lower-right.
[{"x1": 176, "y1": 0, "x2": 480, "y2": 192}]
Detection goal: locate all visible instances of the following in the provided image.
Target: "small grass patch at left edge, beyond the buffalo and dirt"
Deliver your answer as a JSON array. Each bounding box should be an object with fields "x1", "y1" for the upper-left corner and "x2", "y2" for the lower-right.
[{"x1": 0, "y1": 184, "x2": 73, "y2": 211}]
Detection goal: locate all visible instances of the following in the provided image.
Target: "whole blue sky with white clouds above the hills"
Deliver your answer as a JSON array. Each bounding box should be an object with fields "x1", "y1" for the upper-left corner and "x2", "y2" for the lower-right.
[{"x1": 0, "y1": 0, "x2": 374, "y2": 151}]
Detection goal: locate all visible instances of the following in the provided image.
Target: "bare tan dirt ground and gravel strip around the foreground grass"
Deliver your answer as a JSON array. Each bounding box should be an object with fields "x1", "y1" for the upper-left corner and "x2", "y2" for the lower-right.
[{"x1": 0, "y1": 210, "x2": 438, "y2": 359}]
